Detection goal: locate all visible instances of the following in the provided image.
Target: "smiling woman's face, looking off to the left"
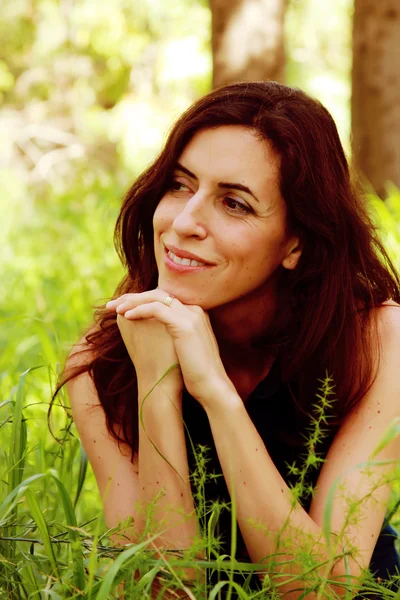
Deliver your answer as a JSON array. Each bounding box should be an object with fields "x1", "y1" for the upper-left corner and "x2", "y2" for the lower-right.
[{"x1": 153, "y1": 126, "x2": 301, "y2": 310}]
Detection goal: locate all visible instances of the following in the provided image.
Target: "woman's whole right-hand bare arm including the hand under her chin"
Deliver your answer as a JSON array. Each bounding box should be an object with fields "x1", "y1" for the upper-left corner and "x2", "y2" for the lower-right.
[{"x1": 111, "y1": 298, "x2": 400, "y2": 598}]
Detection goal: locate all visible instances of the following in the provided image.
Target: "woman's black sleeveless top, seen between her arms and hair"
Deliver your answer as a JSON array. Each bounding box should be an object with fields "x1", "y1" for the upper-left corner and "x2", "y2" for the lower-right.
[{"x1": 183, "y1": 359, "x2": 400, "y2": 597}]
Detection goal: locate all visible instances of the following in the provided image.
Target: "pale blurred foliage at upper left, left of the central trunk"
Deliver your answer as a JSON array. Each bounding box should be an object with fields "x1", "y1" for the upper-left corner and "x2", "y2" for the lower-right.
[{"x1": 0, "y1": 0, "x2": 211, "y2": 202}]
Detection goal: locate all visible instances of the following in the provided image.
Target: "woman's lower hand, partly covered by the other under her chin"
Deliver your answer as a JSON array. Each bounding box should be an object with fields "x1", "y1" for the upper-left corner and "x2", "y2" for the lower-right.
[{"x1": 107, "y1": 290, "x2": 183, "y2": 397}]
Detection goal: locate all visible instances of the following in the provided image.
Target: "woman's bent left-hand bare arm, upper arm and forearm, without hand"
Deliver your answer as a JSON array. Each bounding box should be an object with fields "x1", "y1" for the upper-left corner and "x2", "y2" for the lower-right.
[{"x1": 67, "y1": 322, "x2": 197, "y2": 549}]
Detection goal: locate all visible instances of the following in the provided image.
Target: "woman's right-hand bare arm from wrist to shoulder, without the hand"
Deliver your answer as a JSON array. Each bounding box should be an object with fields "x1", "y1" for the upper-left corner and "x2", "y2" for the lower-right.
[{"x1": 203, "y1": 309, "x2": 400, "y2": 598}]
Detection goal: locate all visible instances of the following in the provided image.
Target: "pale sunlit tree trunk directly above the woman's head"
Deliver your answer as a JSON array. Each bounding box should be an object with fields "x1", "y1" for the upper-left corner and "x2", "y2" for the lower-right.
[{"x1": 210, "y1": 0, "x2": 286, "y2": 87}]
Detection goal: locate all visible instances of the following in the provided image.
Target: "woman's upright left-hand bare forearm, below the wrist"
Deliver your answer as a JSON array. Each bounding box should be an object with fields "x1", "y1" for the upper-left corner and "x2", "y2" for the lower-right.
[{"x1": 139, "y1": 382, "x2": 197, "y2": 550}]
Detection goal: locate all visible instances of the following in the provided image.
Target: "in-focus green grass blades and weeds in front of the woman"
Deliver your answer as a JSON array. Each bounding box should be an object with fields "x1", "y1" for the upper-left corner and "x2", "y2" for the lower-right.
[{"x1": 0, "y1": 370, "x2": 395, "y2": 600}]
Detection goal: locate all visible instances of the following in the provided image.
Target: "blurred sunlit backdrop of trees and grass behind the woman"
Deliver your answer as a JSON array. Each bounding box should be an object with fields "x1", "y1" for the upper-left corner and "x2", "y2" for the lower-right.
[{"x1": 0, "y1": 0, "x2": 400, "y2": 568}]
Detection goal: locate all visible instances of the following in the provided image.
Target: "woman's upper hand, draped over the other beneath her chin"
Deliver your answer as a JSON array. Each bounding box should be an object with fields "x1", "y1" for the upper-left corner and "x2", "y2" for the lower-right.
[{"x1": 107, "y1": 288, "x2": 236, "y2": 405}]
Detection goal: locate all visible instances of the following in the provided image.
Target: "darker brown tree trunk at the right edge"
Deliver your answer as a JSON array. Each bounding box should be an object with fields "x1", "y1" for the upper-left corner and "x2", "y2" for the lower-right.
[{"x1": 352, "y1": 0, "x2": 400, "y2": 198}]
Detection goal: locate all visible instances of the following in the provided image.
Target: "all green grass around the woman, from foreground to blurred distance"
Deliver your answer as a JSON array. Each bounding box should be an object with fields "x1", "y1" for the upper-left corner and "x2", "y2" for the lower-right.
[{"x1": 0, "y1": 181, "x2": 400, "y2": 600}]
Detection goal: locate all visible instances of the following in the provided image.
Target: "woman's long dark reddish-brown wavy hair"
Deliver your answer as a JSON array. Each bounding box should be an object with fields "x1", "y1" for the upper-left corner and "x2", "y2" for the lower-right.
[{"x1": 57, "y1": 82, "x2": 400, "y2": 456}]
